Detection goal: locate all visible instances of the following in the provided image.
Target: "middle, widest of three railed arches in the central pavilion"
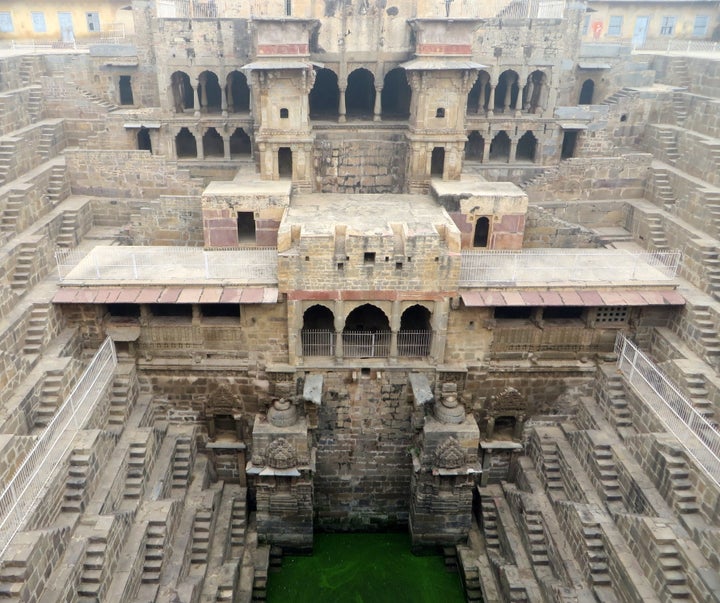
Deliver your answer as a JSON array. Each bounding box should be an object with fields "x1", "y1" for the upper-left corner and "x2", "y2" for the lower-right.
[{"x1": 343, "y1": 304, "x2": 390, "y2": 358}]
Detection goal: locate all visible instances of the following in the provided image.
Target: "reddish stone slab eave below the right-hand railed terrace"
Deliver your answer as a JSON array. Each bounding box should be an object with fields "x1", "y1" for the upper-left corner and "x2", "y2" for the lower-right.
[{"x1": 460, "y1": 289, "x2": 685, "y2": 307}]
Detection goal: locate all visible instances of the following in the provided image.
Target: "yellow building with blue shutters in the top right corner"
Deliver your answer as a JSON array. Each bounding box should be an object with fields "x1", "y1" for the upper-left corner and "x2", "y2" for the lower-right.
[{"x1": 582, "y1": 0, "x2": 720, "y2": 48}]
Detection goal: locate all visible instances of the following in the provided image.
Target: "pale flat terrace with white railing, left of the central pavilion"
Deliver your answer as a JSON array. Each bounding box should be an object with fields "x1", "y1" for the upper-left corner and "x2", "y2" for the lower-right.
[{"x1": 55, "y1": 246, "x2": 277, "y2": 285}]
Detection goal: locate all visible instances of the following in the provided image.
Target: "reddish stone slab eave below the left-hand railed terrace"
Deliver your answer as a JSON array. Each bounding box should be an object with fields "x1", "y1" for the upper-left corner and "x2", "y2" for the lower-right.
[{"x1": 52, "y1": 287, "x2": 278, "y2": 304}]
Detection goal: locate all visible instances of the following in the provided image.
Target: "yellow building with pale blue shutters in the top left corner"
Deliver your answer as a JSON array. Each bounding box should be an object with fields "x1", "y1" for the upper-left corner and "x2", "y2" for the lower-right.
[{"x1": 0, "y1": 0, "x2": 133, "y2": 42}]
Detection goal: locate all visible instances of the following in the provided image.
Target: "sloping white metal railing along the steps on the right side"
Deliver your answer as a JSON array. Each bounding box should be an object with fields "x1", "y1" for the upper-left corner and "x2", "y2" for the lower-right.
[{"x1": 615, "y1": 333, "x2": 720, "y2": 486}]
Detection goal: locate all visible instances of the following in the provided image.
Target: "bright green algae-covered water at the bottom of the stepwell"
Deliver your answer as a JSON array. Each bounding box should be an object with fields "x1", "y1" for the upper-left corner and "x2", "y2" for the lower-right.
[{"x1": 267, "y1": 534, "x2": 465, "y2": 603}]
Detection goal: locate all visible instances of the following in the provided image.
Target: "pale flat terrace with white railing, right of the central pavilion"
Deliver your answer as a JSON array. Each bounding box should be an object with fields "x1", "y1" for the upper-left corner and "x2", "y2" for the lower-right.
[{"x1": 460, "y1": 249, "x2": 681, "y2": 287}]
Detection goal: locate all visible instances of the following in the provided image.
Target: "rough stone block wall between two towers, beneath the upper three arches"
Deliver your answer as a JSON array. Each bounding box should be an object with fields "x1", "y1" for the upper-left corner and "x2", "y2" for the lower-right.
[{"x1": 313, "y1": 128, "x2": 408, "y2": 193}]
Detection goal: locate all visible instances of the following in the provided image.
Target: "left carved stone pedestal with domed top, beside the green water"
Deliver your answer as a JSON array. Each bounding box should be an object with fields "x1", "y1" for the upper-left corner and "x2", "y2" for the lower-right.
[{"x1": 247, "y1": 403, "x2": 315, "y2": 553}]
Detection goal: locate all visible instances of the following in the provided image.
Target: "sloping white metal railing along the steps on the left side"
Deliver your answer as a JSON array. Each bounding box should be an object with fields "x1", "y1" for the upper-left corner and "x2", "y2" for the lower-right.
[{"x1": 0, "y1": 337, "x2": 117, "y2": 559}]
